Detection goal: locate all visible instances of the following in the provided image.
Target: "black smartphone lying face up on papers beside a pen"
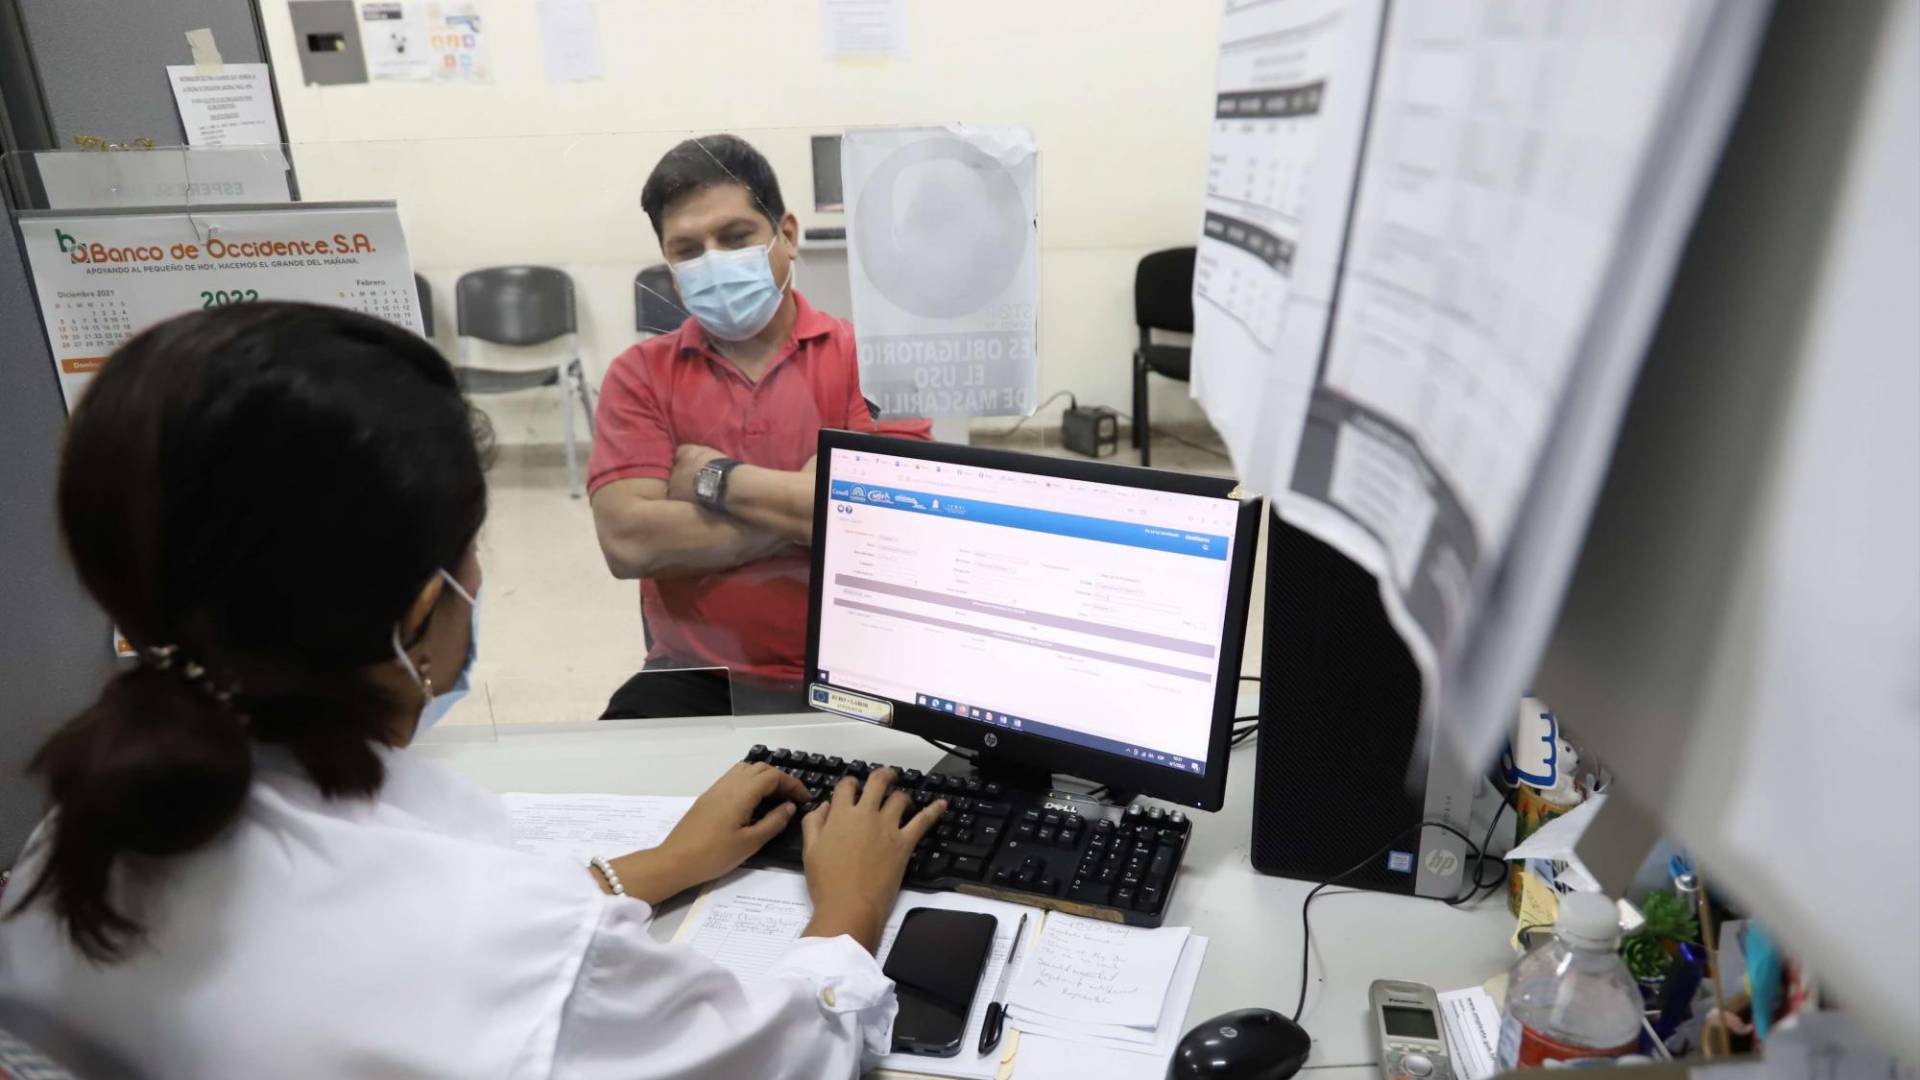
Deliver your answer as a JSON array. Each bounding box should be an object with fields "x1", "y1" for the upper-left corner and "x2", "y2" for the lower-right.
[{"x1": 881, "y1": 907, "x2": 998, "y2": 1057}]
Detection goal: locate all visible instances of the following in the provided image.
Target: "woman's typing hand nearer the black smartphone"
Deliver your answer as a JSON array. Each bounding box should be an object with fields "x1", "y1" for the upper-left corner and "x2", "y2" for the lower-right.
[{"x1": 801, "y1": 769, "x2": 947, "y2": 953}]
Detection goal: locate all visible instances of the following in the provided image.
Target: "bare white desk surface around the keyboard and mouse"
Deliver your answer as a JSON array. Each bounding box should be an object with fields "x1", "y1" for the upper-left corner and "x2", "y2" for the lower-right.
[{"x1": 415, "y1": 713, "x2": 1513, "y2": 1080}]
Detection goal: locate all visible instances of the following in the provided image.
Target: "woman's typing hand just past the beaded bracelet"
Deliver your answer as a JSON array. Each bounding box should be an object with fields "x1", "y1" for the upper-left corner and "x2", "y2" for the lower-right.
[{"x1": 614, "y1": 761, "x2": 806, "y2": 903}]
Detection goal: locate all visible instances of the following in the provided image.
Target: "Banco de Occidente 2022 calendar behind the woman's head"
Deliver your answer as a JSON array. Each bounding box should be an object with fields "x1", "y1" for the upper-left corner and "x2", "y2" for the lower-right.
[{"x1": 19, "y1": 202, "x2": 422, "y2": 413}]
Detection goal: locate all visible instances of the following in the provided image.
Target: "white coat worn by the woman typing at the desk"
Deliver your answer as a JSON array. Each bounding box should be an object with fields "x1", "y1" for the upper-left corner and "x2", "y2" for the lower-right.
[{"x1": 0, "y1": 749, "x2": 895, "y2": 1080}]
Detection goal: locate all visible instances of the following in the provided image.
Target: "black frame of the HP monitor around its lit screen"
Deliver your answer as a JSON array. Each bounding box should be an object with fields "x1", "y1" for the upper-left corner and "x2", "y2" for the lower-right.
[{"x1": 806, "y1": 429, "x2": 1260, "y2": 811}]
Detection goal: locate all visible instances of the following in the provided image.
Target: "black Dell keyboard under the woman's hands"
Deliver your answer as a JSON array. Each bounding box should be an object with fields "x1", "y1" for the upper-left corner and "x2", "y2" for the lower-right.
[{"x1": 747, "y1": 746, "x2": 1192, "y2": 926}]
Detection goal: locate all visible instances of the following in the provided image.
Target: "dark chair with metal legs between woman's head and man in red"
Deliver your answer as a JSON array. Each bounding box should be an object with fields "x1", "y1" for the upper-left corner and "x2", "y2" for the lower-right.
[{"x1": 453, "y1": 267, "x2": 593, "y2": 498}]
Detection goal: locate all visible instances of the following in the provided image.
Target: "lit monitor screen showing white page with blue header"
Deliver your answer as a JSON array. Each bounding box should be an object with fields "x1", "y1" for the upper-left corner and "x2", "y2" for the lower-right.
[{"x1": 814, "y1": 448, "x2": 1238, "y2": 774}]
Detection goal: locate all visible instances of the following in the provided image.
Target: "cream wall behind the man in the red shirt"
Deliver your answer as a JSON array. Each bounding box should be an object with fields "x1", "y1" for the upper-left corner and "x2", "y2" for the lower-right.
[{"x1": 263, "y1": 0, "x2": 1219, "y2": 442}]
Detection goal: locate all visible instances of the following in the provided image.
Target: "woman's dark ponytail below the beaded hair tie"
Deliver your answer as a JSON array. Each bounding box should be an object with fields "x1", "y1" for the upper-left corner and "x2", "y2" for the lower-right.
[{"x1": 21, "y1": 667, "x2": 253, "y2": 961}]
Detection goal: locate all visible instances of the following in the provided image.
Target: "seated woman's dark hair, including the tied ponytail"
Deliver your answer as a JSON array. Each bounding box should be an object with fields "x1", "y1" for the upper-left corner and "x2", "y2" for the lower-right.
[{"x1": 8, "y1": 302, "x2": 486, "y2": 963}]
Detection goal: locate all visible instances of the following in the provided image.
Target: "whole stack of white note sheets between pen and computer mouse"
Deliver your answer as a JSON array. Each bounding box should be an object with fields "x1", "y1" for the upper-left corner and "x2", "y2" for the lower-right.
[{"x1": 1008, "y1": 911, "x2": 1206, "y2": 1080}]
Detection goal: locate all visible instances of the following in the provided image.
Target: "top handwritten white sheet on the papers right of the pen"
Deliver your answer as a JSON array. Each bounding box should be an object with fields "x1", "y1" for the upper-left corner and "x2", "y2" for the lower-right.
[{"x1": 1010, "y1": 911, "x2": 1188, "y2": 1028}]
